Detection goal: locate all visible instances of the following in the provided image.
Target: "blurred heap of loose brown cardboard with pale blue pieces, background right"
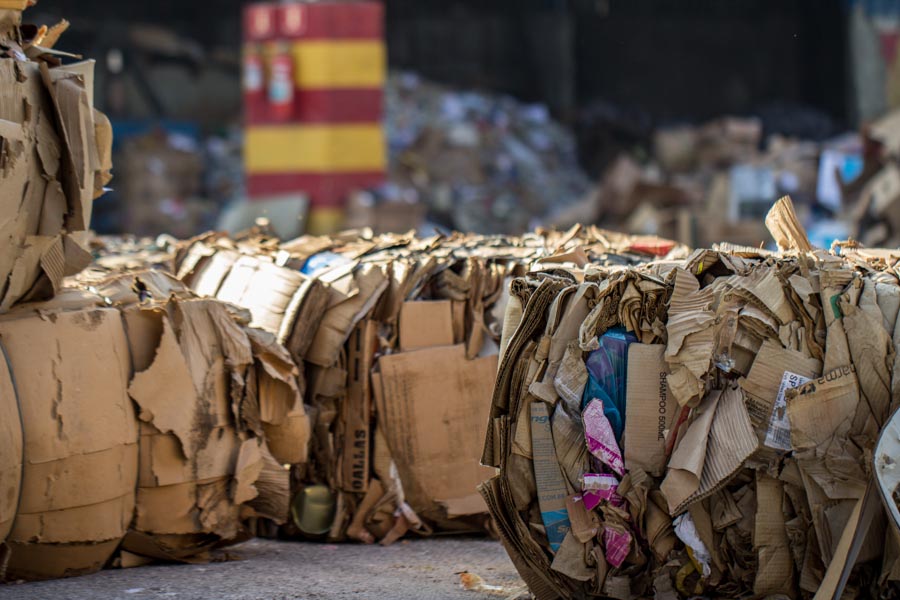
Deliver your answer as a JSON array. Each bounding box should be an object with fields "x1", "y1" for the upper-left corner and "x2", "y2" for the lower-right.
[{"x1": 555, "y1": 115, "x2": 844, "y2": 247}]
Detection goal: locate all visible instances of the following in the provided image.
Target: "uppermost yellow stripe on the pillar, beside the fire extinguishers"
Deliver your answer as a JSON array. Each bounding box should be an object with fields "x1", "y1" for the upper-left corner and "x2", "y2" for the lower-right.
[{"x1": 291, "y1": 40, "x2": 386, "y2": 89}]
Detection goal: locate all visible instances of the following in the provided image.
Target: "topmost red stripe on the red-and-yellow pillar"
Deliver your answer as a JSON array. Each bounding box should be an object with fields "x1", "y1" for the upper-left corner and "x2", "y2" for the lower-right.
[{"x1": 277, "y1": 2, "x2": 384, "y2": 40}]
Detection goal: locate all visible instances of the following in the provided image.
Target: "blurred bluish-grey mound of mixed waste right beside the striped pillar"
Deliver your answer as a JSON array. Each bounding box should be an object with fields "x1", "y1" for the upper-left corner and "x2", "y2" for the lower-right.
[{"x1": 347, "y1": 72, "x2": 591, "y2": 234}]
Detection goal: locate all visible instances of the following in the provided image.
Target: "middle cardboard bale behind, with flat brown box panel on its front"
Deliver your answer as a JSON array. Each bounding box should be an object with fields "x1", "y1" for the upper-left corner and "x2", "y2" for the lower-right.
[{"x1": 176, "y1": 228, "x2": 674, "y2": 543}]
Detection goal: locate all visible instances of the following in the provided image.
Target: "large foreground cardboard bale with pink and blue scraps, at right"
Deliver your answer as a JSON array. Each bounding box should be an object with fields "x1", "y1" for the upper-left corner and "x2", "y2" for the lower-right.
[{"x1": 481, "y1": 198, "x2": 900, "y2": 599}]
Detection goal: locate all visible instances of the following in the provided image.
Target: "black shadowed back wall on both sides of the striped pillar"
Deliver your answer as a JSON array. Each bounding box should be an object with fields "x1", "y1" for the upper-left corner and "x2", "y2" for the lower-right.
[{"x1": 30, "y1": 0, "x2": 848, "y2": 129}]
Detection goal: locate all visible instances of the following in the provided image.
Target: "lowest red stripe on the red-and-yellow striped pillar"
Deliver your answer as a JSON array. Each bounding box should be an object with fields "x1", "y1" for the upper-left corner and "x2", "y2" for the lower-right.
[{"x1": 247, "y1": 172, "x2": 385, "y2": 207}]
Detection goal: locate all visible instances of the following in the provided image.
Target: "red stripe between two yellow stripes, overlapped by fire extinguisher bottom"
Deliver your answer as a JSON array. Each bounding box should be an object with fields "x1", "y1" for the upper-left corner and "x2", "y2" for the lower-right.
[{"x1": 244, "y1": 88, "x2": 384, "y2": 126}]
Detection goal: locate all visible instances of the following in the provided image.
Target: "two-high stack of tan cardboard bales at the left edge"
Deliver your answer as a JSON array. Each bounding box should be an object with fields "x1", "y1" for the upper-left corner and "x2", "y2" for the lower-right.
[{"x1": 0, "y1": 7, "x2": 292, "y2": 581}]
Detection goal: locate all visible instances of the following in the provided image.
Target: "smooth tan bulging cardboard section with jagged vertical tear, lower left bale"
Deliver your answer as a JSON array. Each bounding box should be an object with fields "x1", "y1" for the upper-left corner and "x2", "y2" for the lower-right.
[{"x1": 0, "y1": 307, "x2": 138, "y2": 580}]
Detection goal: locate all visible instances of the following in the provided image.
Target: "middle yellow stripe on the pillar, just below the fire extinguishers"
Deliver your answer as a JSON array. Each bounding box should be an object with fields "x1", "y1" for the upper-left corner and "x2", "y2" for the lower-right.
[{"x1": 244, "y1": 123, "x2": 387, "y2": 175}]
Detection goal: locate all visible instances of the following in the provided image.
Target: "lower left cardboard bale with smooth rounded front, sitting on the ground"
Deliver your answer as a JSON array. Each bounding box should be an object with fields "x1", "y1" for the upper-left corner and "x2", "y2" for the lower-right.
[{"x1": 0, "y1": 271, "x2": 296, "y2": 580}]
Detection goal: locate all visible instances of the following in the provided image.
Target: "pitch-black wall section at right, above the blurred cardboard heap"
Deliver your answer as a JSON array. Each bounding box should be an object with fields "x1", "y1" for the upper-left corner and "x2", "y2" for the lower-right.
[{"x1": 577, "y1": 0, "x2": 847, "y2": 124}]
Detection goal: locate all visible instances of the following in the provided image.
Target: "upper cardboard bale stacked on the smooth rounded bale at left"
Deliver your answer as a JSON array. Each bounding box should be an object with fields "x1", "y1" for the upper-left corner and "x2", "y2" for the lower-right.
[{"x1": 0, "y1": 8, "x2": 112, "y2": 312}]
